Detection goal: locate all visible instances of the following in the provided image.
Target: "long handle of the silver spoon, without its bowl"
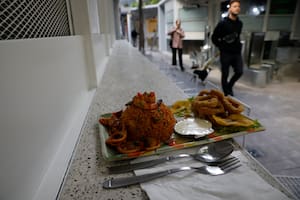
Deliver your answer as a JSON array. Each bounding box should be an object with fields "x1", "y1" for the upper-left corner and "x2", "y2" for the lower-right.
[{"x1": 107, "y1": 154, "x2": 193, "y2": 174}]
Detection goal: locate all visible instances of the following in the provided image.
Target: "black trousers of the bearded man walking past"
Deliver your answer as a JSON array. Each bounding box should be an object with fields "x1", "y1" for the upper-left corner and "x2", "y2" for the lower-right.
[{"x1": 220, "y1": 52, "x2": 243, "y2": 95}]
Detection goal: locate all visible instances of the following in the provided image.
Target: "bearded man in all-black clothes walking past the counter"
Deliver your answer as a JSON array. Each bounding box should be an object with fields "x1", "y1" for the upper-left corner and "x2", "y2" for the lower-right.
[{"x1": 212, "y1": 0, "x2": 243, "y2": 96}]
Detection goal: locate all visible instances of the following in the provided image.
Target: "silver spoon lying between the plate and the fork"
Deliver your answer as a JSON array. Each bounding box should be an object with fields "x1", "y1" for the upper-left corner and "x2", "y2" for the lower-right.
[{"x1": 108, "y1": 141, "x2": 233, "y2": 174}]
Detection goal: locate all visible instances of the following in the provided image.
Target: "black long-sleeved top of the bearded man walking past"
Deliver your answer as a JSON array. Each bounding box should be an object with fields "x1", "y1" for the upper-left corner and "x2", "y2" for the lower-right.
[{"x1": 212, "y1": 17, "x2": 243, "y2": 53}]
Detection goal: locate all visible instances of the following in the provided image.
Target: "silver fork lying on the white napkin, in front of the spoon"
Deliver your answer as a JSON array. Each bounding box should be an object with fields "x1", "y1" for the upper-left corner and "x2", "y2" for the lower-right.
[{"x1": 103, "y1": 157, "x2": 241, "y2": 189}]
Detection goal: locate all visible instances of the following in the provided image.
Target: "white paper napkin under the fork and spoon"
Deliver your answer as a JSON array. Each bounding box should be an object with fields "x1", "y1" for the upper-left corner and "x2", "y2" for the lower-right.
[{"x1": 135, "y1": 151, "x2": 289, "y2": 200}]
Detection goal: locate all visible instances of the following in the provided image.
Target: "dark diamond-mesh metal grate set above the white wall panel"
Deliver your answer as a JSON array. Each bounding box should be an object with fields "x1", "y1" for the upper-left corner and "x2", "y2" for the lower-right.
[{"x1": 0, "y1": 0, "x2": 70, "y2": 40}]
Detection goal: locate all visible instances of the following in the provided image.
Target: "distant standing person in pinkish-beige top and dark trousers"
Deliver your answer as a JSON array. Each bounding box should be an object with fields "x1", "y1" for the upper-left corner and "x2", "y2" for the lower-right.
[{"x1": 168, "y1": 19, "x2": 184, "y2": 71}]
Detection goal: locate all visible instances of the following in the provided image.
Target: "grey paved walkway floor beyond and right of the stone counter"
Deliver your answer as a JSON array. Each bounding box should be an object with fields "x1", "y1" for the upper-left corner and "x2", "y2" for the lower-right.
[{"x1": 146, "y1": 52, "x2": 300, "y2": 176}]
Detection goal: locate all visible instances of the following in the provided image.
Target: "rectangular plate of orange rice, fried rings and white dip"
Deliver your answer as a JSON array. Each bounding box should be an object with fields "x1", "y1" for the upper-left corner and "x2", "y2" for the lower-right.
[{"x1": 99, "y1": 91, "x2": 264, "y2": 161}]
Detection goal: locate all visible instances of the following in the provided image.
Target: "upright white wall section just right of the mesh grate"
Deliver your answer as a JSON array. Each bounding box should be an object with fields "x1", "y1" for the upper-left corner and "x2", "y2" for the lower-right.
[{"x1": 71, "y1": 0, "x2": 118, "y2": 83}]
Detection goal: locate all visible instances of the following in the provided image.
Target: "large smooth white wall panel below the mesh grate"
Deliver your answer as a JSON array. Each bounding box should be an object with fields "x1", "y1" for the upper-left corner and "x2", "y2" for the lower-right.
[{"x1": 0, "y1": 36, "x2": 94, "y2": 200}]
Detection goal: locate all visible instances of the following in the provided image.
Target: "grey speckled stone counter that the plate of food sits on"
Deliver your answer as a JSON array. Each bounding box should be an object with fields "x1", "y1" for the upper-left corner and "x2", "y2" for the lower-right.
[{"x1": 58, "y1": 41, "x2": 187, "y2": 200}]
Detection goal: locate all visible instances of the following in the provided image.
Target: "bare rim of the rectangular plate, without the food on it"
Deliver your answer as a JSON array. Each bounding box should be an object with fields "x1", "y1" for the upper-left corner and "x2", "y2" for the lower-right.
[{"x1": 99, "y1": 114, "x2": 265, "y2": 161}]
